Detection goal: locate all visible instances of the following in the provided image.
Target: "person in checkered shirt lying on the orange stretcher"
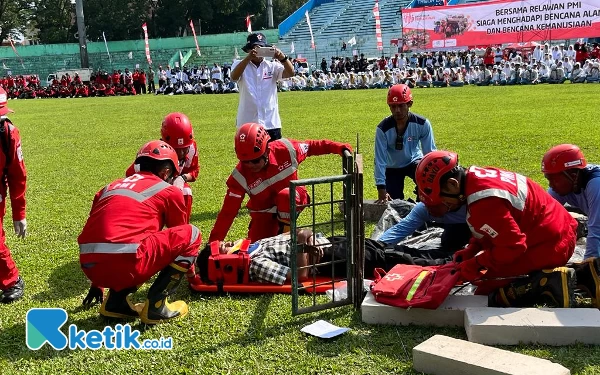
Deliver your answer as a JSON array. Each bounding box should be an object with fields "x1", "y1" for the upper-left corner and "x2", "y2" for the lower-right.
[{"x1": 197, "y1": 229, "x2": 331, "y2": 285}]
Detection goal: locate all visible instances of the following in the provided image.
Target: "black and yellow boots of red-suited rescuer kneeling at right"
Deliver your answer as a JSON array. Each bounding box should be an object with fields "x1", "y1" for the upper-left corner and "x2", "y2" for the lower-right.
[{"x1": 488, "y1": 267, "x2": 577, "y2": 308}]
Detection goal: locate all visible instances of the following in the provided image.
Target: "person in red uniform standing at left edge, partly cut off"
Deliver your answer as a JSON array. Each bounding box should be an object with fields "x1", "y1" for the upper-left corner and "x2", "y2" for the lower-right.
[{"x1": 0, "y1": 88, "x2": 27, "y2": 303}]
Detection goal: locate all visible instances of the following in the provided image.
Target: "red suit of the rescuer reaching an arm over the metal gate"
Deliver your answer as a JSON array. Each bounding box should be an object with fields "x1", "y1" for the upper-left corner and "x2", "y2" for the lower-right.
[{"x1": 209, "y1": 138, "x2": 348, "y2": 242}]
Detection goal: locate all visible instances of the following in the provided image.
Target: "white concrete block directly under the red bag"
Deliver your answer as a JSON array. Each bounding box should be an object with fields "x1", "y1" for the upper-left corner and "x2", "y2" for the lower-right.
[{"x1": 361, "y1": 292, "x2": 487, "y2": 327}]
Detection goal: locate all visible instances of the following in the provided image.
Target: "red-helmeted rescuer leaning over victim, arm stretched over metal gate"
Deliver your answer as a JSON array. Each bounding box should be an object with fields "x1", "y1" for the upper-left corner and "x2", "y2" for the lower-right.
[{"x1": 209, "y1": 123, "x2": 352, "y2": 242}]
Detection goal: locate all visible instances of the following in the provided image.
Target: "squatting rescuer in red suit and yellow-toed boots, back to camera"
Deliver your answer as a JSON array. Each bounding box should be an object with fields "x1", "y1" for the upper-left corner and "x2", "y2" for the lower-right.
[{"x1": 78, "y1": 141, "x2": 202, "y2": 324}]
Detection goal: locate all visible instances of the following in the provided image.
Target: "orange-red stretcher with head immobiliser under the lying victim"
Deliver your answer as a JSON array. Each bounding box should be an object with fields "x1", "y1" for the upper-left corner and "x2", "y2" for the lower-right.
[{"x1": 189, "y1": 240, "x2": 346, "y2": 294}]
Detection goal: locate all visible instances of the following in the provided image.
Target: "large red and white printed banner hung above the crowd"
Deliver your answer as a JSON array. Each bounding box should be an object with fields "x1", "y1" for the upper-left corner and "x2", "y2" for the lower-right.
[{"x1": 402, "y1": 0, "x2": 600, "y2": 49}]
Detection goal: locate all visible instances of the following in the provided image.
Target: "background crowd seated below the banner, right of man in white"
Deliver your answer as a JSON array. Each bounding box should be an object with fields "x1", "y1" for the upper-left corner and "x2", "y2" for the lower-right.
[{"x1": 280, "y1": 43, "x2": 600, "y2": 91}]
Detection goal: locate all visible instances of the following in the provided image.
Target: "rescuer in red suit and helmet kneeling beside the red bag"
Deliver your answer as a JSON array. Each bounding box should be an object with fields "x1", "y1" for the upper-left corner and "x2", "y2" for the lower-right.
[{"x1": 416, "y1": 151, "x2": 577, "y2": 307}]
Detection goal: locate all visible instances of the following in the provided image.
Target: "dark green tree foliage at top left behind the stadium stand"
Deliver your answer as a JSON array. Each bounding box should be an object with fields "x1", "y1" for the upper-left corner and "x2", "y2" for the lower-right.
[{"x1": 25, "y1": 0, "x2": 305, "y2": 43}]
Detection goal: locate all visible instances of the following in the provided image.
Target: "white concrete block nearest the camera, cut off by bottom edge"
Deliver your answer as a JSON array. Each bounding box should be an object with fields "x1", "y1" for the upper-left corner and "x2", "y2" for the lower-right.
[{"x1": 413, "y1": 335, "x2": 571, "y2": 375}]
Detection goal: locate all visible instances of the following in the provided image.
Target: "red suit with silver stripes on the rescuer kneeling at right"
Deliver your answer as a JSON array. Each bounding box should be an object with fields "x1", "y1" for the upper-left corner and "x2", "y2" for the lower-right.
[{"x1": 465, "y1": 166, "x2": 577, "y2": 294}]
